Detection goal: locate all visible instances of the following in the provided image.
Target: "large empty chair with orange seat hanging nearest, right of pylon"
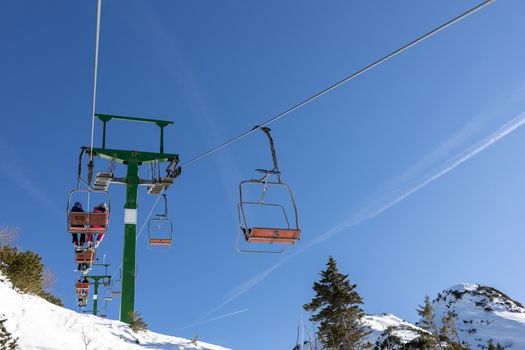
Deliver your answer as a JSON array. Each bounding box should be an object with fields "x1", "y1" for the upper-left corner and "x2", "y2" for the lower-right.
[{"x1": 237, "y1": 127, "x2": 301, "y2": 253}]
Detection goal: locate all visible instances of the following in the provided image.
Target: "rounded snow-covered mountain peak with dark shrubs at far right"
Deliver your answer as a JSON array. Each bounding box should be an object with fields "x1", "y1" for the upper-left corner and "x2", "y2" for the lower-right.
[{"x1": 432, "y1": 283, "x2": 525, "y2": 350}]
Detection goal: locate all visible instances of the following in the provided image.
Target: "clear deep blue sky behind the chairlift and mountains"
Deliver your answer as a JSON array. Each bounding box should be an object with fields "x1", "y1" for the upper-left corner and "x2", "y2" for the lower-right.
[{"x1": 0, "y1": 0, "x2": 525, "y2": 350}]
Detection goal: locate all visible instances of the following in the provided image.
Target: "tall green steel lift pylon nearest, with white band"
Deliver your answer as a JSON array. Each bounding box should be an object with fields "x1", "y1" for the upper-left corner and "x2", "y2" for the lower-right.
[{"x1": 82, "y1": 114, "x2": 180, "y2": 323}]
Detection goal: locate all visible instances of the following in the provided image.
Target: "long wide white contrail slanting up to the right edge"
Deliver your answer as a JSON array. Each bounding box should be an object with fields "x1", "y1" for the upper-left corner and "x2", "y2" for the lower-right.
[{"x1": 201, "y1": 112, "x2": 525, "y2": 319}]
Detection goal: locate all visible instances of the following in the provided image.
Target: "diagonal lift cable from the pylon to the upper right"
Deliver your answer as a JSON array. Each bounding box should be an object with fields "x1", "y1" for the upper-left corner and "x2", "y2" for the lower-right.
[{"x1": 181, "y1": 0, "x2": 496, "y2": 167}]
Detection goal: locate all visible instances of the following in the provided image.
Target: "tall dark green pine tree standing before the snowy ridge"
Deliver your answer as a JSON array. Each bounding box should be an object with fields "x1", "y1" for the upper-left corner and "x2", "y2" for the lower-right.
[{"x1": 303, "y1": 256, "x2": 368, "y2": 350}]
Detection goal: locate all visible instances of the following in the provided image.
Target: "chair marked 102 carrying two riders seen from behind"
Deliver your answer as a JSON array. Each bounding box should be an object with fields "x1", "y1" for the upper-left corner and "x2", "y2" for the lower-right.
[{"x1": 67, "y1": 188, "x2": 111, "y2": 234}]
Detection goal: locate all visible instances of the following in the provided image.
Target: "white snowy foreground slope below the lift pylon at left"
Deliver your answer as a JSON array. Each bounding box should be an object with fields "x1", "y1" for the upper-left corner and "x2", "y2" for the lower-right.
[{"x1": 0, "y1": 274, "x2": 227, "y2": 350}]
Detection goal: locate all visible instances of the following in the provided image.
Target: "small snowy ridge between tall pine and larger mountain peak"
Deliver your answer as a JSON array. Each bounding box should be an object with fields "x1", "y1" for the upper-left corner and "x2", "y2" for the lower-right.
[{"x1": 363, "y1": 314, "x2": 425, "y2": 348}]
